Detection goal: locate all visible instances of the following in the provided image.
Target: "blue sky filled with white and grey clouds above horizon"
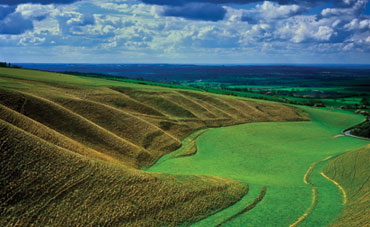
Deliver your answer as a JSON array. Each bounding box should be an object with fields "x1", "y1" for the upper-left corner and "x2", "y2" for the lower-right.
[{"x1": 0, "y1": 0, "x2": 370, "y2": 64}]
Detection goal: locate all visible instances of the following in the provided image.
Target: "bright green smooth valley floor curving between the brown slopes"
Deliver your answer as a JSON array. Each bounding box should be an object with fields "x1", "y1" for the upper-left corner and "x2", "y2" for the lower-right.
[{"x1": 149, "y1": 107, "x2": 368, "y2": 226}]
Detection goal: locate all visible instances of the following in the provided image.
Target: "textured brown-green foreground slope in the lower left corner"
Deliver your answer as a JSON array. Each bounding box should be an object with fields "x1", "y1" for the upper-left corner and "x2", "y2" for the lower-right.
[{"x1": 0, "y1": 121, "x2": 248, "y2": 226}]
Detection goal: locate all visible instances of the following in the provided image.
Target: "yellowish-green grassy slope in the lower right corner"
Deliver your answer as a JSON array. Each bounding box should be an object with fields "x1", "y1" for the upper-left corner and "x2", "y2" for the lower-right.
[{"x1": 324, "y1": 145, "x2": 370, "y2": 226}]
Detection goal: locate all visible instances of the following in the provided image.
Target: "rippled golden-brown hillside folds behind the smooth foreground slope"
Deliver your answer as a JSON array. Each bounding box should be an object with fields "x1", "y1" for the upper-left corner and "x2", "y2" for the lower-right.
[{"x1": 0, "y1": 82, "x2": 302, "y2": 168}]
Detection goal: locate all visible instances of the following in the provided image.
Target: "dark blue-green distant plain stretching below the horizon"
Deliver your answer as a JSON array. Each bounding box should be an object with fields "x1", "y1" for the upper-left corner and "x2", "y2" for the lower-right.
[{"x1": 23, "y1": 64, "x2": 370, "y2": 112}]
